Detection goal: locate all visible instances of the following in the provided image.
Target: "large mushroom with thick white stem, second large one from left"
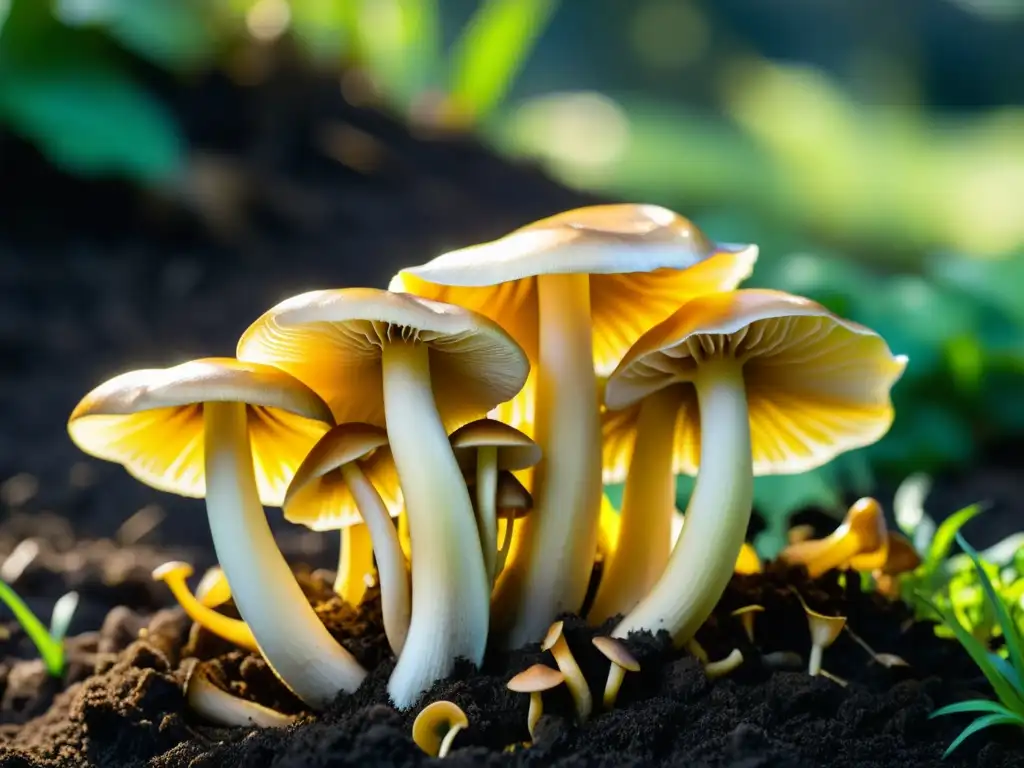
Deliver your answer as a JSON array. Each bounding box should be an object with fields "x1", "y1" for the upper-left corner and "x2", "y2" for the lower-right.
[{"x1": 238, "y1": 288, "x2": 529, "y2": 708}]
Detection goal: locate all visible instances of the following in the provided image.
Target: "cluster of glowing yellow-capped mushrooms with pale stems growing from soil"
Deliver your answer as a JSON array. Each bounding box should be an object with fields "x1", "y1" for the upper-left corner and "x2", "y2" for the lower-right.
[{"x1": 68, "y1": 204, "x2": 905, "y2": 709}]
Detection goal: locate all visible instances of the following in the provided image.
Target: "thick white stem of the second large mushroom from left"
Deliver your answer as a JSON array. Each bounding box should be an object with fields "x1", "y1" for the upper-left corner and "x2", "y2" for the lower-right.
[{"x1": 383, "y1": 343, "x2": 490, "y2": 708}]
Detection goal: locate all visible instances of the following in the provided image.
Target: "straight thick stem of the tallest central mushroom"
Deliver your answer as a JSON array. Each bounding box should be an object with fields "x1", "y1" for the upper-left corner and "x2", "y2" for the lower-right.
[{"x1": 496, "y1": 274, "x2": 602, "y2": 647}]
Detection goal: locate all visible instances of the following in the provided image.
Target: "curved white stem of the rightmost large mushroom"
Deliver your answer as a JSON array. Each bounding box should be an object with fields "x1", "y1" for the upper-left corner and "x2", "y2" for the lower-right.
[{"x1": 612, "y1": 359, "x2": 754, "y2": 645}]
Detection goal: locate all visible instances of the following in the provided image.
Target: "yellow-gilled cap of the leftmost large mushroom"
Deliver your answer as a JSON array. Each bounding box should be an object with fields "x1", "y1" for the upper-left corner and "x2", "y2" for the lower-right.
[{"x1": 68, "y1": 357, "x2": 334, "y2": 507}]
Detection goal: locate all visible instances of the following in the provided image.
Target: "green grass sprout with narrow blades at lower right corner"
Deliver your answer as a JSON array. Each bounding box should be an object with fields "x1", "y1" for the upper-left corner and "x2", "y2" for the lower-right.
[{"x1": 919, "y1": 534, "x2": 1024, "y2": 758}]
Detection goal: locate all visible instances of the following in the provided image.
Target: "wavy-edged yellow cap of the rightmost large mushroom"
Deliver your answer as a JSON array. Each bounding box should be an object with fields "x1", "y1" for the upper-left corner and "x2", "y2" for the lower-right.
[{"x1": 603, "y1": 290, "x2": 906, "y2": 482}]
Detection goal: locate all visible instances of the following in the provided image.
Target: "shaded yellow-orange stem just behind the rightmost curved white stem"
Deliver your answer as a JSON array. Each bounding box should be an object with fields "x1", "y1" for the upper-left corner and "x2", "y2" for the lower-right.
[{"x1": 589, "y1": 387, "x2": 679, "y2": 624}]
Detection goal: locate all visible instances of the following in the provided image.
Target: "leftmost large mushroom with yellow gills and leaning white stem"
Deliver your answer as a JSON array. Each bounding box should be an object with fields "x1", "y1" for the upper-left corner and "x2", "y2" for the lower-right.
[{"x1": 68, "y1": 357, "x2": 366, "y2": 708}]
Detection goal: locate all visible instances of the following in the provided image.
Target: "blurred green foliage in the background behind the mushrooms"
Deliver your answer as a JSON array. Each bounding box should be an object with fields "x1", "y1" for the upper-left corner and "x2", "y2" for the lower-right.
[{"x1": 0, "y1": 0, "x2": 1024, "y2": 528}]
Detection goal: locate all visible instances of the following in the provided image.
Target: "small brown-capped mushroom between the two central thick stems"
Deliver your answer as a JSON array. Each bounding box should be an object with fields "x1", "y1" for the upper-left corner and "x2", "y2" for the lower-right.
[{"x1": 449, "y1": 419, "x2": 541, "y2": 583}]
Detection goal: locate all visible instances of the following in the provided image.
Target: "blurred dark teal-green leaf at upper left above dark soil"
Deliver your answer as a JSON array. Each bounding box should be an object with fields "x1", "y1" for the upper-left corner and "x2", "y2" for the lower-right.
[{"x1": 0, "y1": 51, "x2": 184, "y2": 182}]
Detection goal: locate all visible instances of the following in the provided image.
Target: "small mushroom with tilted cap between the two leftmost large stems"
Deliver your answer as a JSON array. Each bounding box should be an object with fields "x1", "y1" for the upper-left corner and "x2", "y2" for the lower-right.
[{"x1": 284, "y1": 422, "x2": 412, "y2": 655}]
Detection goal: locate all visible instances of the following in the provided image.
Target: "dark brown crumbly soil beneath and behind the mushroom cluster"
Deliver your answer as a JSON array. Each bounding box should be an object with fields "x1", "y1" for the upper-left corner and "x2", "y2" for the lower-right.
[{"x1": 0, "y1": 43, "x2": 1024, "y2": 768}]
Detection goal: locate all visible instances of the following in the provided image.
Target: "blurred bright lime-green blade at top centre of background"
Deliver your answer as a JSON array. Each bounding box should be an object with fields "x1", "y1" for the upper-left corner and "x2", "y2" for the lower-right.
[{"x1": 451, "y1": 0, "x2": 558, "y2": 120}]
